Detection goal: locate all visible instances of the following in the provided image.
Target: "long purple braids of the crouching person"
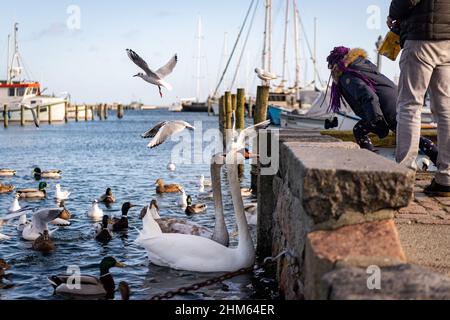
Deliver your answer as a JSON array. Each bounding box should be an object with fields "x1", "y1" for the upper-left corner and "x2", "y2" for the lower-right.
[{"x1": 327, "y1": 47, "x2": 375, "y2": 113}]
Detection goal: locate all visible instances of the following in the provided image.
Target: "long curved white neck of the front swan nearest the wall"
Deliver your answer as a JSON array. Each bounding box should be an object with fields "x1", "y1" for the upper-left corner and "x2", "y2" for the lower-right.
[{"x1": 227, "y1": 164, "x2": 255, "y2": 254}]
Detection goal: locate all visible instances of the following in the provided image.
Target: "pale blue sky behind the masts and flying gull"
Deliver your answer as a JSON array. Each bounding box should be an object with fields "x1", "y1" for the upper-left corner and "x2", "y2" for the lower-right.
[{"x1": 0, "y1": 0, "x2": 399, "y2": 105}]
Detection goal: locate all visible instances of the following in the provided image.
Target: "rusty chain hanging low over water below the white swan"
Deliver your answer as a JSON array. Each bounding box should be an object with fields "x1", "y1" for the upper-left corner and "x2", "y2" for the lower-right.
[{"x1": 150, "y1": 251, "x2": 289, "y2": 301}]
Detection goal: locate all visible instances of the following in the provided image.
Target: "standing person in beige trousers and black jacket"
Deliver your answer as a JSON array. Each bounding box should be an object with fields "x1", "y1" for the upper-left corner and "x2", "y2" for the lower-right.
[{"x1": 387, "y1": 0, "x2": 450, "y2": 197}]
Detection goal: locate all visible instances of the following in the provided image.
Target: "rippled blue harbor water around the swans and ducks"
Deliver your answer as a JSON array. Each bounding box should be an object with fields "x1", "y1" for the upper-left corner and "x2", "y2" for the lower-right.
[{"x1": 0, "y1": 111, "x2": 277, "y2": 300}]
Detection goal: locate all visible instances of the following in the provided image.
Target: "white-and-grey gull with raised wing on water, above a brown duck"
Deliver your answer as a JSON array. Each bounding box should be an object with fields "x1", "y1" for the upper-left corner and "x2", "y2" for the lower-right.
[{"x1": 22, "y1": 208, "x2": 69, "y2": 241}]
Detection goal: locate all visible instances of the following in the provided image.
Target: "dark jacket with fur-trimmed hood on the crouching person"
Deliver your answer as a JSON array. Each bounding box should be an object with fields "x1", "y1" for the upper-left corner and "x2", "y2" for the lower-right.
[{"x1": 339, "y1": 57, "x2": 398, "y2": 130}]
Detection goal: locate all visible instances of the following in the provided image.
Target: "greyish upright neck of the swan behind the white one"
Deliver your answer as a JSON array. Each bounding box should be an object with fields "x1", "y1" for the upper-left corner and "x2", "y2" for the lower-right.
[{"x1": 211, "y1": 163, "x2": 230, "y2": 246}]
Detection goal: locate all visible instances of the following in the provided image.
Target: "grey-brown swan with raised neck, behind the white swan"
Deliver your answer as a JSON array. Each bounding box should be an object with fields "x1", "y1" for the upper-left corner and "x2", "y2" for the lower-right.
[{"x1": 141, "y1": 153, "x2": 230, "y2": 247}]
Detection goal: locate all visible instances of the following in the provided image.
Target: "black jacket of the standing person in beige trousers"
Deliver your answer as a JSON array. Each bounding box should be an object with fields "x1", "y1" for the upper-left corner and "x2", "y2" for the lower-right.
[{"x1": 389, "y1": 0, "x2": 450, "y2": 46}]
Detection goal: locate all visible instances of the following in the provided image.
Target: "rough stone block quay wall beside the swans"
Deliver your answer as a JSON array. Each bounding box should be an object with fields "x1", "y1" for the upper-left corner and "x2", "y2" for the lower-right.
[{"x1": 258, "y1": 131, "x2": 450, "y2": 300}]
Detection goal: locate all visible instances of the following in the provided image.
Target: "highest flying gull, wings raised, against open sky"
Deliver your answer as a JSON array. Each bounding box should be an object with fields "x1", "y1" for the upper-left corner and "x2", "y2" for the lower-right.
[{"x1": 127, "y1": 49, "x2": 178, "y2": 98}]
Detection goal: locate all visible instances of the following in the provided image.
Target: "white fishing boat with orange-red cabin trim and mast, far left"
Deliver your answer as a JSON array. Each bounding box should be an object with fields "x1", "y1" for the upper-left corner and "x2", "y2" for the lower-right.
[{"x1": 0, "y1": 23, "x2": 70, "y2": 124}]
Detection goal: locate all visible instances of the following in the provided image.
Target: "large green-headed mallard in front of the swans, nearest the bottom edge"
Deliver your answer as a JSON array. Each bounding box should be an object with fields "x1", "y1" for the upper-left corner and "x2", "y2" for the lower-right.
[{"x1": 48, "y1": 257, "x2": 125, "y2": 300}]
